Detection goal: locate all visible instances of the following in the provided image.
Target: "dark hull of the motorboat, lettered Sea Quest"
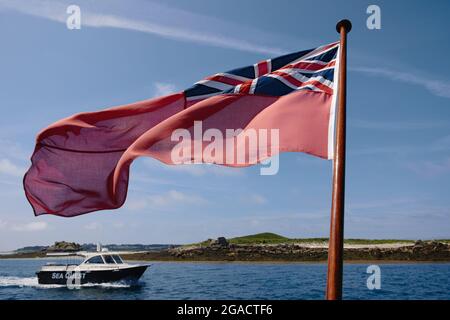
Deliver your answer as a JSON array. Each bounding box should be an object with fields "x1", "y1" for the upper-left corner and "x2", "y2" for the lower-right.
[{"x1": 36, "y1": 265, "x2": 148, "y2": 285}]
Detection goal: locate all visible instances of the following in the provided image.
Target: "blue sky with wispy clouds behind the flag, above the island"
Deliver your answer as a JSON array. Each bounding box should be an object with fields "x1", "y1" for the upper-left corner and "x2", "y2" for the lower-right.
[{"x1": 0, "y1": 0, "x2": 450, "y2": 250}]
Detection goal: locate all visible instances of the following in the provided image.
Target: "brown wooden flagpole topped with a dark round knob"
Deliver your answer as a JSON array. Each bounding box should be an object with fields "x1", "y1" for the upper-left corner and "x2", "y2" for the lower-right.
[{"x1": 326, "y1": 20, "x2": 352, "y2": 300}]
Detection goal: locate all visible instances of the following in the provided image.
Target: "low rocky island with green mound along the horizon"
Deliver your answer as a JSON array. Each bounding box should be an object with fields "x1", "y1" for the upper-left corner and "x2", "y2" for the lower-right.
[{"x1": 0, "y1": 232, "x2": 450, "y2": 262}]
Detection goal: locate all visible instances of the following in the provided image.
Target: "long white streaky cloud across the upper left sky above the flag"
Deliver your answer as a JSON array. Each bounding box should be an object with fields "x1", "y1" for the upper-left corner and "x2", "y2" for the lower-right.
[{"x1": 0, "y1": 0, "x2": 284, "y2": 54}]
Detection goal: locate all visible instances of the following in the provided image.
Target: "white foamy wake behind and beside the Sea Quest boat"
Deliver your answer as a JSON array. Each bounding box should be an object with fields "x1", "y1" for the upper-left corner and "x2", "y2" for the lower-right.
[{"x1": 0, "y1": 277, "x2": 132, "y2": 289}]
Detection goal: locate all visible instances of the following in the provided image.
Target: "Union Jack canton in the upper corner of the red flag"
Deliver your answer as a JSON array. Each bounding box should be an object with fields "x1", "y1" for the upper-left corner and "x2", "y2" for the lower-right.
[{"x1": 184, "y1": 42, "x2": 339, "y2": 102}]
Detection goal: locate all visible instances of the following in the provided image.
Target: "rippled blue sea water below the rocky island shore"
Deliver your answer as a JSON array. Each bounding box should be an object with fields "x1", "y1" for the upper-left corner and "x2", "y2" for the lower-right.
[{"x1": 0, "y1": 259, "x2": 450, "y2": 300}]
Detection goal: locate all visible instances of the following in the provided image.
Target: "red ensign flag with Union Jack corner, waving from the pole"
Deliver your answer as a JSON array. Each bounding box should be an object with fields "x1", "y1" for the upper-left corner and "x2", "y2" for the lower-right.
[{"x1": 24, "y1": 42, "x2": 339, "y2": 217}]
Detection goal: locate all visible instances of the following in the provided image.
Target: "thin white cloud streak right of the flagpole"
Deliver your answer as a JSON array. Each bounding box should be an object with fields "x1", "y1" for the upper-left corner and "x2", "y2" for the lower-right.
[{"x1": 350, "y1": 67, "x2": 450, "y2": 98}]
